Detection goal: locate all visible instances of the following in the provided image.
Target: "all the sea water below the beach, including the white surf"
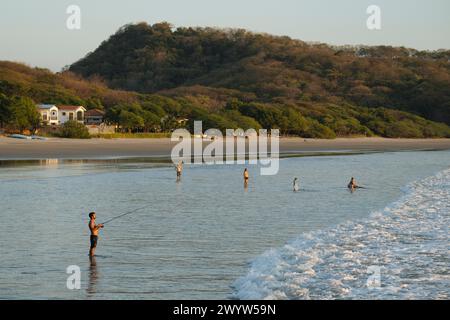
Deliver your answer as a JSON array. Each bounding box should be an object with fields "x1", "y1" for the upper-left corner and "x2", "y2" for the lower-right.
[{"x1": 0, "y1": 151, "x2": 450, "y2": 299}]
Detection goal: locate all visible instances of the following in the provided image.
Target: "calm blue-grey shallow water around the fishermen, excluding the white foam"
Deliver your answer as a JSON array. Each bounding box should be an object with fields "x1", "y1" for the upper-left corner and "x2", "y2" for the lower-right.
[{"x1": 0, "y1": 152, "x2": 450, "y2": 299}]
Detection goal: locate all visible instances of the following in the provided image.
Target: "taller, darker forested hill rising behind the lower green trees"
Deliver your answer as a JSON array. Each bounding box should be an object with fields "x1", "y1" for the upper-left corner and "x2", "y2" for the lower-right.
[{"x1": 70, "y1": 23, "x2": 450, "y2": 124}]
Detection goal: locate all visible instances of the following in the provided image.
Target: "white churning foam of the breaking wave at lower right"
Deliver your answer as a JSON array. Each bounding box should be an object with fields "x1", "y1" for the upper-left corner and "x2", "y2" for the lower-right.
[{"x1": 234, "y1": 169, "x2": 450, "y2": 299}]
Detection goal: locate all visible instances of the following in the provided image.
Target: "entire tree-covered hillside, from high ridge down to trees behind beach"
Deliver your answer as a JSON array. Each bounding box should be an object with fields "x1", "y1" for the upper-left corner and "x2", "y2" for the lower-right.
[{"x1": 0, "y1": 23, "x2": 450, "y2": 138}]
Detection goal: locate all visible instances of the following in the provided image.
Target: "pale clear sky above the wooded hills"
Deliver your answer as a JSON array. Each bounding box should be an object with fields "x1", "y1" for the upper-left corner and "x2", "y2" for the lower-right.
[{"x1": 0, "y1": 0, "x2": 450, "y2": 71}]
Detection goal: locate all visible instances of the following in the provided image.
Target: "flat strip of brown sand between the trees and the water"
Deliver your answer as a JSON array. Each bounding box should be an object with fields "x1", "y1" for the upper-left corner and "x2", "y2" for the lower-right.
[{"x1": 0, "y1": 137, "x2": 450, "y2": 160}]
